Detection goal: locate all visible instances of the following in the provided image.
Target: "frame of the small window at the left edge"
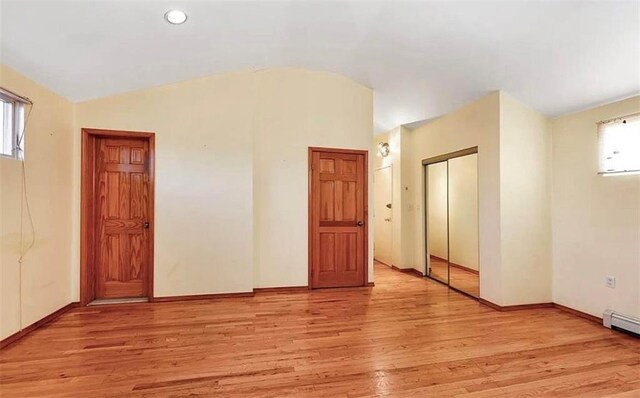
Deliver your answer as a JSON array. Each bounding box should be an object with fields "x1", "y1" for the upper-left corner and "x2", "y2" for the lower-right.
[{"x1": 0, "y1": 88, "x2": 32, "y2": 160}]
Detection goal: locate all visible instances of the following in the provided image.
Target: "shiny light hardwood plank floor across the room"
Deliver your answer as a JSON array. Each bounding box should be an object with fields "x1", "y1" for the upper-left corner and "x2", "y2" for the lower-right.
[{"x1": 0, "y1": 265, "x2": 640, "y2": 398}]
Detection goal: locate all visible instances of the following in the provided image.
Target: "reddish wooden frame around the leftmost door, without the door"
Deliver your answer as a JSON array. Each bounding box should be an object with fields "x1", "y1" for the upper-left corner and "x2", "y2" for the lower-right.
[{"x1": 80, "y1": 128, "x2": 155, "y2": 306}]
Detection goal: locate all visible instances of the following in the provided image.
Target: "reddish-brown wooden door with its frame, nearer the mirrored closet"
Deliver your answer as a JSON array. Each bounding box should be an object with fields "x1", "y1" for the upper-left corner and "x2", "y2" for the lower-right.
[{"x1": 309, "y1": 148, "x2": 367, "y2": 288}]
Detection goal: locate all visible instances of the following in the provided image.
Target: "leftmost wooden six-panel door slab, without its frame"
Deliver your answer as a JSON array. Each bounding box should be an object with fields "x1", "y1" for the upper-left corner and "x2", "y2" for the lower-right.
[{"x1": 94, "y1": 137, "x2": 151, "y2": 299}]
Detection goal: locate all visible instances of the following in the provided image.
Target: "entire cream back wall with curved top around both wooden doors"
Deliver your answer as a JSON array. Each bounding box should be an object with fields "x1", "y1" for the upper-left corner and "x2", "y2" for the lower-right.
[{"x1": 74, "y1": 69, "x2": 373, "y2": 296}]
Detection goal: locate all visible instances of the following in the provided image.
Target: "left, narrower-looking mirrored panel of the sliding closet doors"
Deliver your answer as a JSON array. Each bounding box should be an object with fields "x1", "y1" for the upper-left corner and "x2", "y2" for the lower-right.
[{"x1": 426, "y1": 161, "x2": 449, "y2": 283}]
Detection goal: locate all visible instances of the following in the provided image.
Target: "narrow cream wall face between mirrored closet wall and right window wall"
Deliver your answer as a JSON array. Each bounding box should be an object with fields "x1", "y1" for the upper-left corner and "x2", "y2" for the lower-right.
[{"x1": 500, "y1": 92, "x2": 552, "y2": 305}]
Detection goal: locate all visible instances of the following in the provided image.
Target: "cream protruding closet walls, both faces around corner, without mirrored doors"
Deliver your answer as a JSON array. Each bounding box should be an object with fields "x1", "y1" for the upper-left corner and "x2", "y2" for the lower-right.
[{"x1": 409, "y1": 92, "x2": 551, "y2": 306}]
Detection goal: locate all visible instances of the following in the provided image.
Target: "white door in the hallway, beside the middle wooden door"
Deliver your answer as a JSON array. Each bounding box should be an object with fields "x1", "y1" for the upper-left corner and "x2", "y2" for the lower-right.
[{"x1": 373, "y1": 166, "x2": 393, "y2": 265}]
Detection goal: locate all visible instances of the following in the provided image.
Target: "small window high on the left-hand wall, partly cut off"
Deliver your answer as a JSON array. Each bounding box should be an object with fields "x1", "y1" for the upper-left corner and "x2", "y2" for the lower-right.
[{"x1": 0, "y1": 89, "x2": 28, "y2": 159}]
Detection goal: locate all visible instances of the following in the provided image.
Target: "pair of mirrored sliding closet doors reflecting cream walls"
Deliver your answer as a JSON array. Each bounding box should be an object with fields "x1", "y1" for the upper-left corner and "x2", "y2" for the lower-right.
[{"x1": 423, "y1": 148, "x2": 480, "y2": 297}]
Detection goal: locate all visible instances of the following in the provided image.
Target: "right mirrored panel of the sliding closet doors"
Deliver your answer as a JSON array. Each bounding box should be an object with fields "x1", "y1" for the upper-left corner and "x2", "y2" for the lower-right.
[{"x1": 448, "y1": 154, "x2": 479, "y2": 297}]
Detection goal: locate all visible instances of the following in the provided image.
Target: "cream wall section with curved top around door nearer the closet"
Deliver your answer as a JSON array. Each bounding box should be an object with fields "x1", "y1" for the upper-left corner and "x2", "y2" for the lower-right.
[{"x1": 253, "y1": 69, "x2": 374, "y2": 287}]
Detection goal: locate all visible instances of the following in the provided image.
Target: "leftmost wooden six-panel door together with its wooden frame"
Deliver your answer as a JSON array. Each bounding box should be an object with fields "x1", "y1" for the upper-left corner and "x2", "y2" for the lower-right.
[{"x1": 80, "y1": 129, "x2": 155, "y2": 305}]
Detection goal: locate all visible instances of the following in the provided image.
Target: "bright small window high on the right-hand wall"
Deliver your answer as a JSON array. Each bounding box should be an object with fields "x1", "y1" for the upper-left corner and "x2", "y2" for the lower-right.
[{"x1": 598, "y1": 114, "x2": 640, "y2": 175}]
